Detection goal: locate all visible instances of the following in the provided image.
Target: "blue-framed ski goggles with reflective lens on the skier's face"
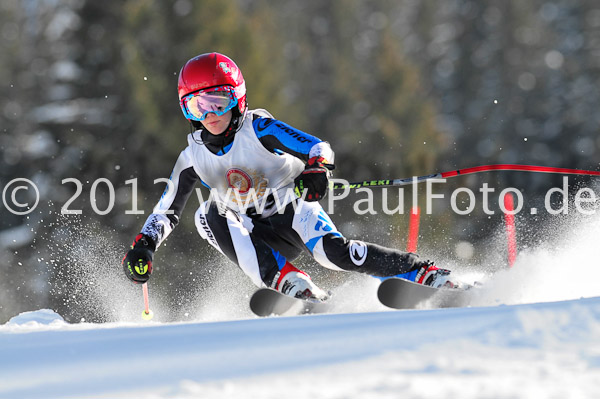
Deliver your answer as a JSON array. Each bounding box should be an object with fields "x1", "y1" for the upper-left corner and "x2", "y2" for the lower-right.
[{"x1": 179, "y1": 86, "x2": 237, "y2": 121}]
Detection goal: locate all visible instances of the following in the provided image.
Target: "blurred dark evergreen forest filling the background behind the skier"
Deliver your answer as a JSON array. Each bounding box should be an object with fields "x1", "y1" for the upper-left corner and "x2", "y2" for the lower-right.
[{"x1": 0, "y1": 0, "x2": 600, "y2": 322}]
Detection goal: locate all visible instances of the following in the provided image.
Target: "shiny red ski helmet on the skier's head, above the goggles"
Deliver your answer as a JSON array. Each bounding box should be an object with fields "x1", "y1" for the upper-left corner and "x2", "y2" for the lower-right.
[{"x1": 177, "y1": 53, "x2": 247, "y2": 120}]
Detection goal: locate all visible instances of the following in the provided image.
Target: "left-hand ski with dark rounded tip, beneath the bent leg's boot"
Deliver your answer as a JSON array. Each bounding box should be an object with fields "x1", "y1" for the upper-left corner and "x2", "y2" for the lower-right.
[{"x1": 250, "y1": 288, "x2": 328, "y2": 317}]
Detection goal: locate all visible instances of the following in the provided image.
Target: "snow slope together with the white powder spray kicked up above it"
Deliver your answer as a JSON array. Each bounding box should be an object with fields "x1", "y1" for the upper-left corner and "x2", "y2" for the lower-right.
[{"x1": 0, "y1": 208, "x2": 600, "y2": 399}]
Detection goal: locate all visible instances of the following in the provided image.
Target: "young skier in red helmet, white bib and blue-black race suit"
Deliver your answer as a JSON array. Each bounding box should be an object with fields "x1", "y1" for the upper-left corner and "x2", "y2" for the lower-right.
[{"x1": 122, "y1": 53, "x2": 451, "y2": 300}]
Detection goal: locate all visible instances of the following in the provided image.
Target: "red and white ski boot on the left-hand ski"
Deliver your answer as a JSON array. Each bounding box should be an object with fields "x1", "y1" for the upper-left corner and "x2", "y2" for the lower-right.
[{"x1": 274, "y1": 262, "x2": 329, "y2": 302}]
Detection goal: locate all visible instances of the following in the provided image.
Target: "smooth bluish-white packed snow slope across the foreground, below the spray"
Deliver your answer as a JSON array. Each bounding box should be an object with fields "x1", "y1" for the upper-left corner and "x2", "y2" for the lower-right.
[{"x1": 0, "y1": 297, "x2": 600, "y2": 399}]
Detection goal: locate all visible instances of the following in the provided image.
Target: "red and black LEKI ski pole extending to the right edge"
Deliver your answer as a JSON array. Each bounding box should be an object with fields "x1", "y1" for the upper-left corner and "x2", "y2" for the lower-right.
[{"x1": 332, "y1": 164, "x2": 600, "y2": 190}]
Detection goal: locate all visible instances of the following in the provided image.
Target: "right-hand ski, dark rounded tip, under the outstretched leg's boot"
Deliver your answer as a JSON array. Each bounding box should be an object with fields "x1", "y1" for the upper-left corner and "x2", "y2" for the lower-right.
[{"x1": 377, "y1": 277, "x2": 473, "y2": 309}]
